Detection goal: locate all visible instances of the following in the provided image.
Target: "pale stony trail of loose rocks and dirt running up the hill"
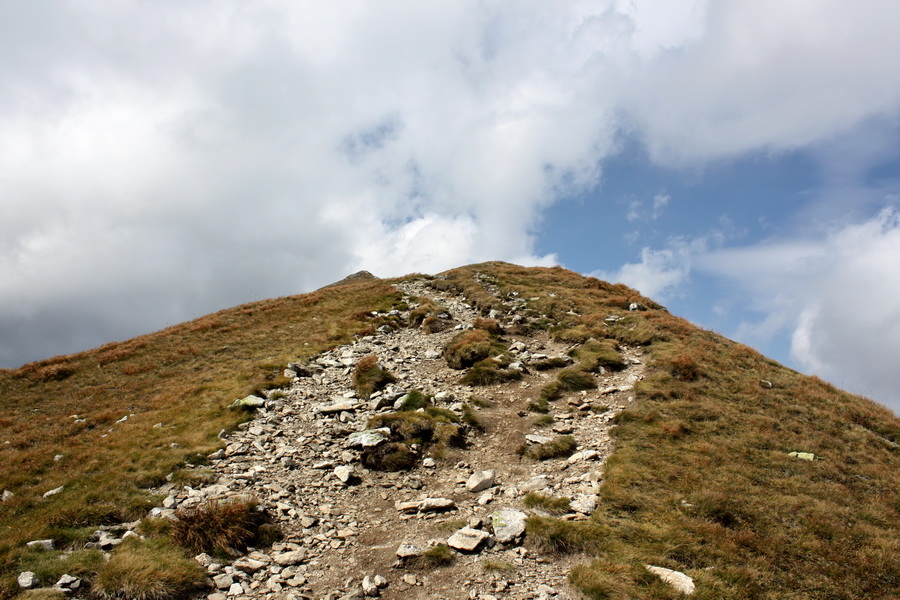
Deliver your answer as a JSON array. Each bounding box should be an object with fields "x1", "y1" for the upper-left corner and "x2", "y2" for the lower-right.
[{"x1": 157, "y1": 281, "x2": 643, "y2": 600}]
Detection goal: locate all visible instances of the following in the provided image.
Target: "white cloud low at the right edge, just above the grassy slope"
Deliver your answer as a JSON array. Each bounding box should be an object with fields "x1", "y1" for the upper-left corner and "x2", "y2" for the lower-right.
[{"x1": 694, "y1": 208, "x2": 900, "y2": 411}]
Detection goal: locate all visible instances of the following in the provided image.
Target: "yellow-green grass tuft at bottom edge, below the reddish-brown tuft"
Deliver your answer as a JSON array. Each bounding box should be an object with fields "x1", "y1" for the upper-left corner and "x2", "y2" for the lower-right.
[{"x1": 92, "y1": 538, "x2": 206, "y2": 600}]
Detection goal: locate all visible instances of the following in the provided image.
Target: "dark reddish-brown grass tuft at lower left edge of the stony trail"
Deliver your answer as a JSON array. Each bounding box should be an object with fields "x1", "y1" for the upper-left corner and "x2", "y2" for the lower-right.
[{"x1": 172, "y1": 500, "x2": 267, "y2": 556}]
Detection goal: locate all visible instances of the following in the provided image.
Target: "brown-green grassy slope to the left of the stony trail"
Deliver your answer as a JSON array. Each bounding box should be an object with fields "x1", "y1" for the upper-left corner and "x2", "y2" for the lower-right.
[{"x1": 0, "y1": 280, "x2": 399, "y2": 597}]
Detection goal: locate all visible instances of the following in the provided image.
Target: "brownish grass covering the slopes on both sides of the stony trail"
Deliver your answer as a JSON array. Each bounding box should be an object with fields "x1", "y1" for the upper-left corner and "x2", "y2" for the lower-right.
[{"x1": 0, "y1": 263, "x2": 900, "y2": 599}]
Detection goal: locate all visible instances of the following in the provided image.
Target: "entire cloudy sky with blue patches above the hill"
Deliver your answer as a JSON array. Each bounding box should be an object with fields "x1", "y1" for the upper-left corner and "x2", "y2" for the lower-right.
[{"x1": 0, "y1": 0, "x2": 900, "y2": 412}]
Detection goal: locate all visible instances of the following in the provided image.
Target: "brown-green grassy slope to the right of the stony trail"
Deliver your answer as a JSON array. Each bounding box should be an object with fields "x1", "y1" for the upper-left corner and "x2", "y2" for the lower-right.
[{"x1": 439, "y1": 264, "x2": 900, "y2": 599}]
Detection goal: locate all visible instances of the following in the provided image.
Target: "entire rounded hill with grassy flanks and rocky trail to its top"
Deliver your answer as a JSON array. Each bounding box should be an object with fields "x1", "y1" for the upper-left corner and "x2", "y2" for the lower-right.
[{"x1": 0, "y1": 262, "x2": 900, "y2": 600}]
